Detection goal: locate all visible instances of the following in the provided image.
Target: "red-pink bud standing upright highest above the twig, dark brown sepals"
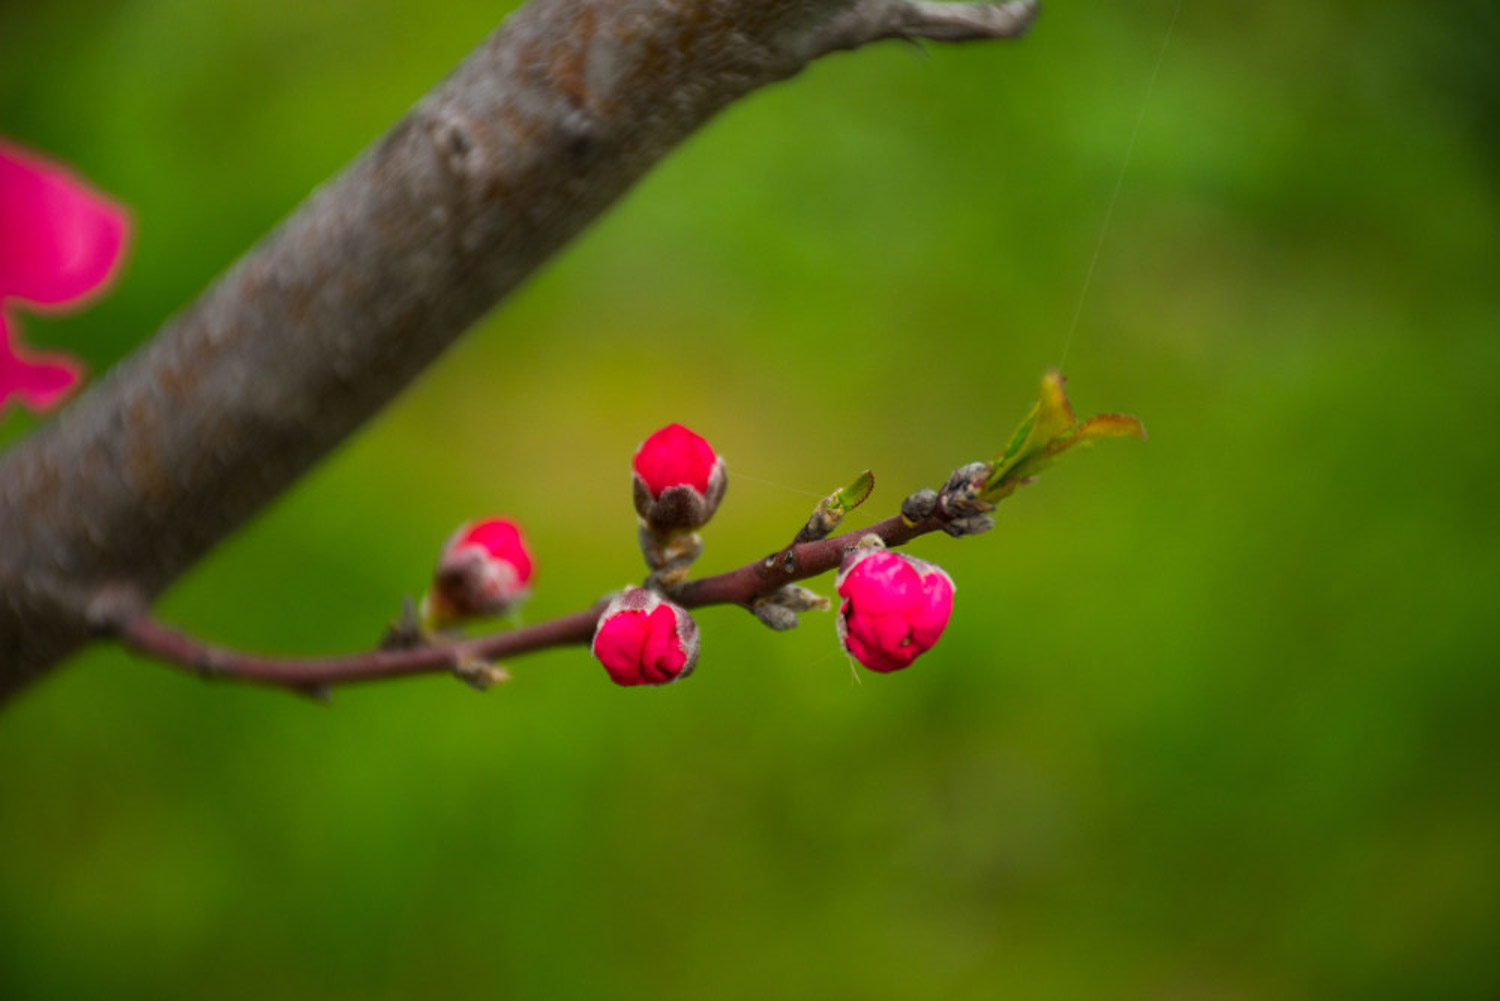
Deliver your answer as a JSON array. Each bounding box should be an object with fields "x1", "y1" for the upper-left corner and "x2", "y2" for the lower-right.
[{"x1": 632, "y1": 425, "x2": 729, "y2": 533}]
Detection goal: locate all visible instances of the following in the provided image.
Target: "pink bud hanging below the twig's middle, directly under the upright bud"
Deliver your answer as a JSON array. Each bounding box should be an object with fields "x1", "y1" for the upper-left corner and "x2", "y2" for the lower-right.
[{"x1": 593, "y1": 587, "x2": 698, "y2": 686}]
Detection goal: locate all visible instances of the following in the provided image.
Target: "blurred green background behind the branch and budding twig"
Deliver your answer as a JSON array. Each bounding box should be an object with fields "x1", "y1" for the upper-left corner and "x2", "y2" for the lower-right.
[{"x1": 0, "y1": 0, "x2": 1500, "y2": 1001}]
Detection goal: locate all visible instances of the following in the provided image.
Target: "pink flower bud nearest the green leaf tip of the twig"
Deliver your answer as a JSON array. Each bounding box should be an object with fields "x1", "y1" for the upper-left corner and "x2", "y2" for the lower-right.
[{"x1": 834, "y1": 546, "x2": 954, "y2": 672}]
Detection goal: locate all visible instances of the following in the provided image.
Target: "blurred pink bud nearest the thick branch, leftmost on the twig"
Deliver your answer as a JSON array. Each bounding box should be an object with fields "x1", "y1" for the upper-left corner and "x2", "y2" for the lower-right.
[{"x1": 423, "y1": 518, "x2": 533, "y2": 627}]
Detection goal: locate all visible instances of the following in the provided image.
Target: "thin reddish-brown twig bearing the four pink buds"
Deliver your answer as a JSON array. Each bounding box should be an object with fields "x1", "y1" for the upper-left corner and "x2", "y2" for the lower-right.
[{"x1": 105, "y1": 515, "x2": 944, "y2": 695}]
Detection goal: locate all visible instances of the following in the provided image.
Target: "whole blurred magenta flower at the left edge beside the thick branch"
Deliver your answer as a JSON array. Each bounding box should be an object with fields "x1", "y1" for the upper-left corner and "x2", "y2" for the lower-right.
[{"x1": 0, "y1": 140, "x2": 129, "y2": 413}]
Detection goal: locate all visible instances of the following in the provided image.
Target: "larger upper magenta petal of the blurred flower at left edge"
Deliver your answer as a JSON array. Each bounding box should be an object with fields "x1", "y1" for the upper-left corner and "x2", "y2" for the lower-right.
[{"x1": 0, "y1": 143, "x2": 129, "y2": 306}]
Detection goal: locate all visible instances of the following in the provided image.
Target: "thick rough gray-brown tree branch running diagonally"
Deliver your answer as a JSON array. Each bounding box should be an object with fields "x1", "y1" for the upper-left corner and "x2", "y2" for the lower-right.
[{"x1": 0, "y1": 0, "x2": 1034, "y2": 701}]
